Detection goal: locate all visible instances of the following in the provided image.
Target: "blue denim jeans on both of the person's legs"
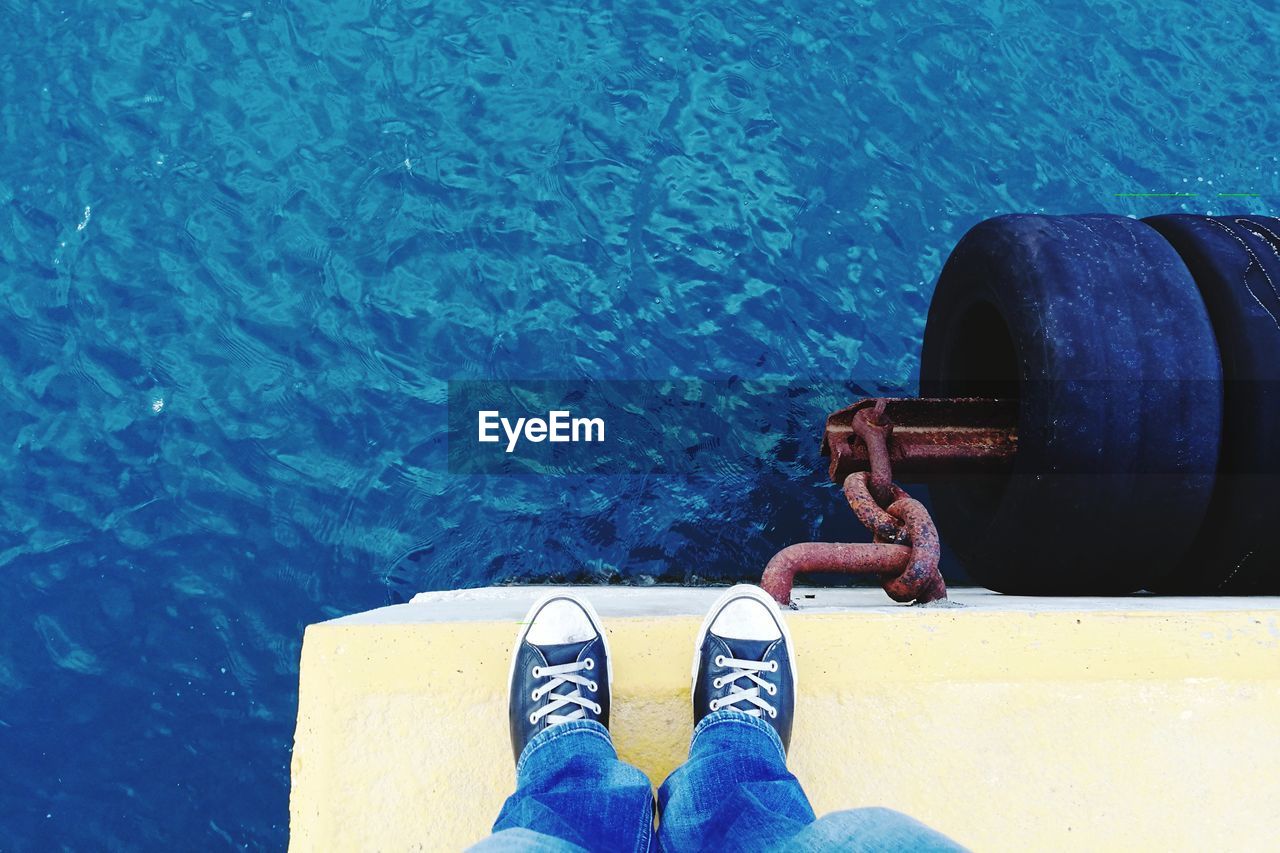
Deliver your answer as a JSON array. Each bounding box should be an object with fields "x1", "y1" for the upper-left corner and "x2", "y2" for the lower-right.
[{"x1": 472, "y1": 710, "x2": 963, "y2": 853}]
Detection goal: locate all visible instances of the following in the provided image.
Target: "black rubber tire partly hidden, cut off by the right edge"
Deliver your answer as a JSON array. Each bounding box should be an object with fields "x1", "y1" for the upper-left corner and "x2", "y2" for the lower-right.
[{"x1": 1144, "y1": 214, "x2": 1280, "y2": 594}]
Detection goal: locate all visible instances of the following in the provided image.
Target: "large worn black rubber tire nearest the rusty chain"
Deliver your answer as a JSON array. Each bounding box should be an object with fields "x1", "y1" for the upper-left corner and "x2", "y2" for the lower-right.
[{"x1": 920, "y1": 214, "x2": 1221, "y2": 594}]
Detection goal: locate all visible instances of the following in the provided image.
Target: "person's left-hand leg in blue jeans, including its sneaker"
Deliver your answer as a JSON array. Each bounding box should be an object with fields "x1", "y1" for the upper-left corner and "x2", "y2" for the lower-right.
[{"x1": 472, "y1": 593, "x2": 653, "y2": 853}]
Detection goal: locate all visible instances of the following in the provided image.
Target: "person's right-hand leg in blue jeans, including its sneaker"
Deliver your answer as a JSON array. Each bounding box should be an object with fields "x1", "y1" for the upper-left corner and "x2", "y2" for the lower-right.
[{"x1": 658, "y1": 585, "x2": 963, "y2": 852}]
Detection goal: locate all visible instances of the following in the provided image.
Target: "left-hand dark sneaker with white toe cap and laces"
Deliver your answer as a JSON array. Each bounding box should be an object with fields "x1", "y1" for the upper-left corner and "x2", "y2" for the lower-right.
[{"x1": 508, "y1": 592, "x2": 613, "y2": 762}]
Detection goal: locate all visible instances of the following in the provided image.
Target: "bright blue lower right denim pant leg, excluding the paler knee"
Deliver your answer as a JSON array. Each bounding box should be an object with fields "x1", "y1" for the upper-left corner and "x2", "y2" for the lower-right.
[{"x1": 658, "y1": 710, "x2": 814, "y2": 853}]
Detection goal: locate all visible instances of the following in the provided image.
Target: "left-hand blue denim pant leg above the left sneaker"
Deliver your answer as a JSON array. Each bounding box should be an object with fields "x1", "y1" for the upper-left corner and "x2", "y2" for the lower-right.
[{"x1": 472, "y1": 720, "x2": 653, "y2": 853}]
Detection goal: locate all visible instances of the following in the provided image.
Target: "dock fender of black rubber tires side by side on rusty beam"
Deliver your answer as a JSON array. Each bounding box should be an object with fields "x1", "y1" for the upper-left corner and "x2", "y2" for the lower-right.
[{"x1": 920, "y1": 214, "x2": 1280, "y2": 594}]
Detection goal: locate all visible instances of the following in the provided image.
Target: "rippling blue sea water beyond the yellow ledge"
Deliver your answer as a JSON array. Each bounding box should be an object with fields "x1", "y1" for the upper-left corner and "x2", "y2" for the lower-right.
[{"x1": 0, "y1": 0, "x2": 1280, "y2": 850}]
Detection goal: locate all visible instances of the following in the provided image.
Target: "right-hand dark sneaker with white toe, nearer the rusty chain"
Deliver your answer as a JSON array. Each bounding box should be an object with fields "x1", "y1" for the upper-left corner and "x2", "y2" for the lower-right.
[{"x1": 694, "y1": 584, "x2": 796, "y2": 749}]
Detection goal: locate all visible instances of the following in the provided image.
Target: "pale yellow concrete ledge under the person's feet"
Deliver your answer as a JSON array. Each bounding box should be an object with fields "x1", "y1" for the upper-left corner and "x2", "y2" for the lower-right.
[{"x1": 289, "y1": 588, "x2": 1280, "y2": 852}]
